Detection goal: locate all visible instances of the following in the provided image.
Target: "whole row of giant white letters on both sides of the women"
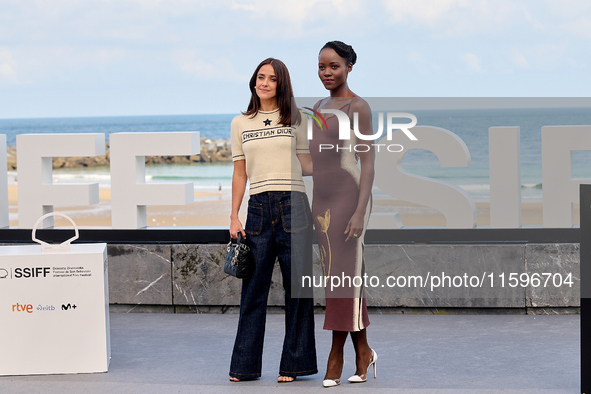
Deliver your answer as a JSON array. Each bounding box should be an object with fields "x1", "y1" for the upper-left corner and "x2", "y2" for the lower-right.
[{"x1": 0, "y1": 121, "x2": 591, "y2": 229}]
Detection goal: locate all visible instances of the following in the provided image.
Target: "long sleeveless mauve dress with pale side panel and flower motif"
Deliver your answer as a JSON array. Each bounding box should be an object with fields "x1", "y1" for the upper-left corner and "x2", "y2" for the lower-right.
[{"x1": 310, "y1": 100, "x2": 371, "y2": 331}]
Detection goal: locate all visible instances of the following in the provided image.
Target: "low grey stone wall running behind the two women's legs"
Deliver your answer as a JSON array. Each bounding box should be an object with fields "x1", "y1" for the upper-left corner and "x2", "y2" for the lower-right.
[{"x1": 108, "y1": 244, "x2": 580, "y2": 313}]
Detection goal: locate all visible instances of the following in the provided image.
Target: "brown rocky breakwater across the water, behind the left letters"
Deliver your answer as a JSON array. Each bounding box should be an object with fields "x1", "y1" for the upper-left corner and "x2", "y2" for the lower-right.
[{"x1": 6, "y1": 137, "x2": 232, "y2": 170}]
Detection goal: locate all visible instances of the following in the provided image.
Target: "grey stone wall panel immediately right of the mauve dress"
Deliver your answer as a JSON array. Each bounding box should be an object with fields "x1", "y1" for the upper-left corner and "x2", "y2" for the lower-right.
[{"x1": 365, "y1": 245, "x2": 525, "y2": 308}]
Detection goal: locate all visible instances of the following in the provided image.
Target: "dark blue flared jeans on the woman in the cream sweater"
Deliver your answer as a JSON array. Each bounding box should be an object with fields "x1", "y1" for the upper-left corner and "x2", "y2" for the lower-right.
[{"x1": 230, "y1": 192, "x2": 318, "y2": 379}]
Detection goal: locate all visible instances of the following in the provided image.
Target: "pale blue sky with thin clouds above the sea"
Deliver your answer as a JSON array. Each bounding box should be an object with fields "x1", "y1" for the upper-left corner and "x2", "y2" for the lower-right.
[{"x1": 0, "y1": 0, "x2": 591, "y2": 118}]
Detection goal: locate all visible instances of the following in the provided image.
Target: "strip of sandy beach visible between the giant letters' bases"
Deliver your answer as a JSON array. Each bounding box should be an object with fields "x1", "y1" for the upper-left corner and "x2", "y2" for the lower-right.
[{"x1": 8, "y1": 185, "x2": 579, "y2": 227}]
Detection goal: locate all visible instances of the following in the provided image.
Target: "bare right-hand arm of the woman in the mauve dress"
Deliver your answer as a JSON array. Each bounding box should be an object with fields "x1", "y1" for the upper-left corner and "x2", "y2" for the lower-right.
[{"x1": 345, "y1": 99, "x2": 375, "y2": 242}]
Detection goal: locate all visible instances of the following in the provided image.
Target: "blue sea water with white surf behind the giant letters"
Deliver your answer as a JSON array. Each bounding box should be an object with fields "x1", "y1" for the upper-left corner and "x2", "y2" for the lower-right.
[{"x1": 0, "y1": 108, "x2": 591, "y2": 202}]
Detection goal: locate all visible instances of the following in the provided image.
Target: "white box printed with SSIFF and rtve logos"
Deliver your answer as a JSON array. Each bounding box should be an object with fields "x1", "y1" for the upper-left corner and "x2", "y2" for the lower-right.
[{"x1": 0, "y1": 243, "x2": 111, "y2": 375}]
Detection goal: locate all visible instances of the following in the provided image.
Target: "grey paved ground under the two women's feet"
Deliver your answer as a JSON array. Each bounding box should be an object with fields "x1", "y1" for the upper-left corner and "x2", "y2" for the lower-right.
[{"x1": 0, "y1": 313, "x2": 581, "y2": 394}]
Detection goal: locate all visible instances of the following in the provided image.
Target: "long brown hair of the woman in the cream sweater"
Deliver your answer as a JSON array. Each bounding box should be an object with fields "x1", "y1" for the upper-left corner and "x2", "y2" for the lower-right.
[{"x1": 242, "y1": 57, "x2": 301, "y2": 126}]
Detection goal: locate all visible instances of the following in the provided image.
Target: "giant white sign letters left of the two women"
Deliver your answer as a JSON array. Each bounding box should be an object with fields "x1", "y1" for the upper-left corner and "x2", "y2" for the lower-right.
[{"x1": 10, "y1": 132, "x2": 200, "y2": 229}]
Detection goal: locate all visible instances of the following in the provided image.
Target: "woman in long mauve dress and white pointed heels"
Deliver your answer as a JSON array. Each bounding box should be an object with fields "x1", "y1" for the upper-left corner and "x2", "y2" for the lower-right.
[{"x1": 310, "y1": 41, "x2": 377, "y2": 387}]
